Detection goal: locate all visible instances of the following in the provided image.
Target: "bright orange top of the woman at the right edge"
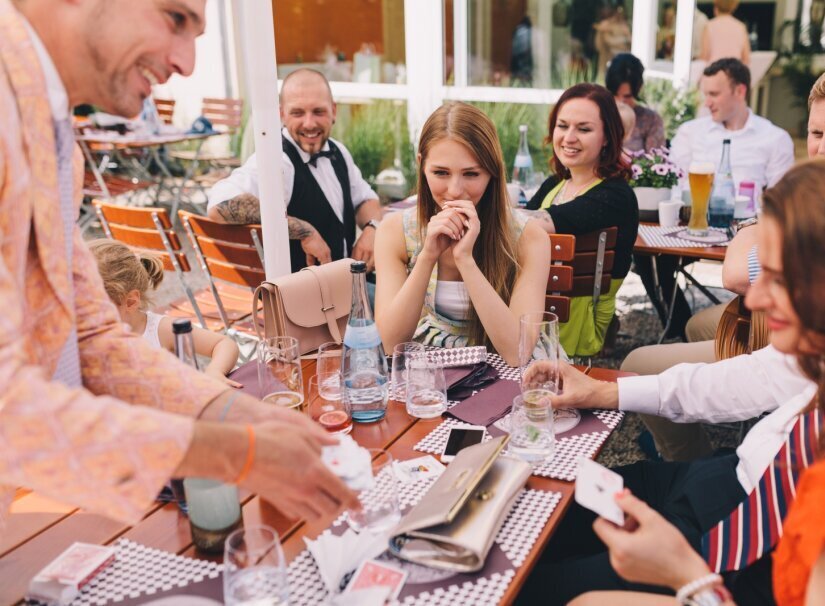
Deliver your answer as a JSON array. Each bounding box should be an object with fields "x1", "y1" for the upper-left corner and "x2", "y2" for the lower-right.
[{"x1": 773, "y1": 460, "x2": 825, "y2": 606}]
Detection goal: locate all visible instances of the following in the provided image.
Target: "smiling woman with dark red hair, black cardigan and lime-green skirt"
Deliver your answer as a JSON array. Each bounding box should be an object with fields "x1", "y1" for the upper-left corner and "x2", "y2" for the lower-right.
[{"x1": 527, "y1": 83, "x2": 639, "y2": 356}]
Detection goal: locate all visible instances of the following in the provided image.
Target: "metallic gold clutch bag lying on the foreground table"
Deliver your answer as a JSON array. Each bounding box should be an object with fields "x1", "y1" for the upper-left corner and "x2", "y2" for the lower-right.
[{"x1": 390, "y1": 436, "x2": 532, "y2": 572}]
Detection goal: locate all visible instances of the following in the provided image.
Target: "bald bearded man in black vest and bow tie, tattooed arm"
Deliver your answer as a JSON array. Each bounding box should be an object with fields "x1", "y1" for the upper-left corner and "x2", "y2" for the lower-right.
[{"x1": 208, "y1": 69, "x2": 382, "y2": 271}]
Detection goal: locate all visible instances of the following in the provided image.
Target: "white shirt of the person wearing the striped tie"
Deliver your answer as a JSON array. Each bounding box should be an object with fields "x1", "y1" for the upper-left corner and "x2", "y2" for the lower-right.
[{"x1": 619, "y1": 346, "x2": 816, "y2": 493}]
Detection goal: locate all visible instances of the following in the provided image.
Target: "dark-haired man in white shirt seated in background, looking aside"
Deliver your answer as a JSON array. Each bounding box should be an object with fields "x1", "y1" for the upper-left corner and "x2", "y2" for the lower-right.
[{"x1": 670, "y1": 59, "x2": 794, "y2": 192}]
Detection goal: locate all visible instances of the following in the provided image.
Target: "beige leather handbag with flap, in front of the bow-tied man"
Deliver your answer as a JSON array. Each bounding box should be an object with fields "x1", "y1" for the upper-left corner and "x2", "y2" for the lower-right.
[{"x1": 252, "y1": 259, "x2": 352, "y2": 354}]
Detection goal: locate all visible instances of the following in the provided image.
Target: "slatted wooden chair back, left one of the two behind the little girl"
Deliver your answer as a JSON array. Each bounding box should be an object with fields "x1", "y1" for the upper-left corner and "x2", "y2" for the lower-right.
[{"x1": 92, "y1": 200, "x2": 206, "y2": 328}]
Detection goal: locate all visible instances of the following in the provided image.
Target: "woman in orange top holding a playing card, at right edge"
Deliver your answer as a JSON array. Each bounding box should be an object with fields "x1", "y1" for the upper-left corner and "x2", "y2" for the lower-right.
[{"x1": 573, "y1": 160, "x2": 825, "y2": 606}]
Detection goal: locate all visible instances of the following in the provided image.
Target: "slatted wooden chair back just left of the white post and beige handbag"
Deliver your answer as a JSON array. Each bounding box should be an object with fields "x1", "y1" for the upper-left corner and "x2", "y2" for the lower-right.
[{"x1": 178, "y1": 210, "x2": 266, "y2": 331}]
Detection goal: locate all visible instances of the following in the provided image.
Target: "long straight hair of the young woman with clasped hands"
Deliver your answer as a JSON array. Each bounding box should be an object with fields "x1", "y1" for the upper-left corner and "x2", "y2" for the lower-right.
[{"x1": 418, "y1": 102, "x2": 519, "y2": 345}]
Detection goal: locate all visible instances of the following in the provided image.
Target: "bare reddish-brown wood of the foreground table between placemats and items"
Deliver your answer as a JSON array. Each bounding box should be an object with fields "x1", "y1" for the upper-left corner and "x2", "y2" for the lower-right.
[{"x1": 0, "y1": 360, "x2": 630, "y2": 605}]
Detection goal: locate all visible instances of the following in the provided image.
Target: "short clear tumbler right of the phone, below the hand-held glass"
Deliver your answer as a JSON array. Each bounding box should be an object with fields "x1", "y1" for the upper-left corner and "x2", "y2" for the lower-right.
[{"x1": 509, "y1": 396, "x2": 556, "y2": 465}]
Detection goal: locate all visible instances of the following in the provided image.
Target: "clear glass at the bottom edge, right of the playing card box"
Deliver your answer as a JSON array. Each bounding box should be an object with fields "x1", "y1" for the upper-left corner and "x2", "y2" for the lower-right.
[{"x1": 223, "y1": 525, "x2": 289, "y2": 606}]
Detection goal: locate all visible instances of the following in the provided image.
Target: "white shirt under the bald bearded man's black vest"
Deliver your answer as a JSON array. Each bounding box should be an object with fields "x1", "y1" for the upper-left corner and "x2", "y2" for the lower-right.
[{"x1": 207, "y1": 129, "x2": 378, "y2": 223}]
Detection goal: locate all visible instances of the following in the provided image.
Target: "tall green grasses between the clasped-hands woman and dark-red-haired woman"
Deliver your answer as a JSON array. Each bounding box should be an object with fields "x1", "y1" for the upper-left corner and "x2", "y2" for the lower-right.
[{"x1": 466, "y1": 102, "x2": 551, "y2": 178}]
